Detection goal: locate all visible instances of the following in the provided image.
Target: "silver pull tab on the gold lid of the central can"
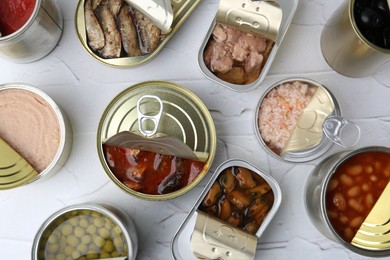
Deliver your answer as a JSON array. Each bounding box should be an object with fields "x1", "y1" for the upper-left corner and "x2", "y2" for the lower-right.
[{"x1": 137, "y1": 95, "x2": 163, "y2": 137}]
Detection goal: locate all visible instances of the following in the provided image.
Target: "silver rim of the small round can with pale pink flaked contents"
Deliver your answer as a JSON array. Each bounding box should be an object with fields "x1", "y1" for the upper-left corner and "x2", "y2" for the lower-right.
[{"x1": 253, "y1": 77, "x2": 341, "y2": 163}]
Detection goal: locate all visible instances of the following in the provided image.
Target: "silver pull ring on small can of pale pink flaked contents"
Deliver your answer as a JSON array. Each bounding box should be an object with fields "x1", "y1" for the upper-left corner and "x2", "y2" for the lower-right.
[{"x1": 323, "y1": 116, "x2": 360, "y2": 148}]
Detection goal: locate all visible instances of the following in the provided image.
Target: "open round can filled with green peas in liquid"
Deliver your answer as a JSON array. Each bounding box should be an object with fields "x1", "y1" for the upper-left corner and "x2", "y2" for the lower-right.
[{"x1": 32, "y1": 204, "x2": 138, "y2": 260}]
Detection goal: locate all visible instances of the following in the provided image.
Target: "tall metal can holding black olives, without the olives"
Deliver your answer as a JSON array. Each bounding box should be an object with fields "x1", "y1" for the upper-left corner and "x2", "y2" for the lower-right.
[{"x1": 321, "y1": 0, "x2": 390, "y2": 77}]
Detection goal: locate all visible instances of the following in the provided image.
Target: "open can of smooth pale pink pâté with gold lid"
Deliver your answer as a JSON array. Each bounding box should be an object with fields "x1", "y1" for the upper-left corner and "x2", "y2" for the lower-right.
[{"x1": 0, "y1": 83, "x2": 72, "y2": 189}]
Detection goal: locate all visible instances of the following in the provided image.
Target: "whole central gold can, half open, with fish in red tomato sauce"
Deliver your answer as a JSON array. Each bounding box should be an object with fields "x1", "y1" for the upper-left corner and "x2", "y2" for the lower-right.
[{"x1": 97, "y1": 81, "x2": 216, "y2": 200}]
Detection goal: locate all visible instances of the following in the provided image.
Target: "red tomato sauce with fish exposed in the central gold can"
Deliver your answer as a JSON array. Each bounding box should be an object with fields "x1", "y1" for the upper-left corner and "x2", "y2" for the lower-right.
[{"x1": 103, "y1": 144, "x2": 205, "y2": 195}]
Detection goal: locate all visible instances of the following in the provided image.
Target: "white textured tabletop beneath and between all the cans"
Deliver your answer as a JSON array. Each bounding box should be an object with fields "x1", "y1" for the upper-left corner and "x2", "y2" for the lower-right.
[{"x1": 0, "y1": 0, "x2": 390, "y2": 260}]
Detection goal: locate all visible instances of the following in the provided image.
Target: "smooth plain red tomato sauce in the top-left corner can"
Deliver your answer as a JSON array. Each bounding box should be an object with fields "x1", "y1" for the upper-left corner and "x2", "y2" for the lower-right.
[{"x1": 0, "y1": 0, "x2": 36, "y2": 36}]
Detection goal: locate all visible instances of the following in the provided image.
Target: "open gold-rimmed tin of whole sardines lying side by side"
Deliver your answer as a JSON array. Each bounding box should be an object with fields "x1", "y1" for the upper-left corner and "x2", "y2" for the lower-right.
[{"x1": 76, "y1": 0, "x2": 200, "y2": 67}]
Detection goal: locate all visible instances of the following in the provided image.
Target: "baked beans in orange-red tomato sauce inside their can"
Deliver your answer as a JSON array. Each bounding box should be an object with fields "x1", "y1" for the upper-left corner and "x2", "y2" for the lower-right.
[{"x1": 326, "y1": 152, "x2": 390, "y2": 242}]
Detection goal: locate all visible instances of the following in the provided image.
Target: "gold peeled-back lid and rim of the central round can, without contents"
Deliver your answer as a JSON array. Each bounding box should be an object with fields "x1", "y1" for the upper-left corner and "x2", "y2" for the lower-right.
[{"x1": 97, "y1": 81, "x2": 216, "y2": 200}]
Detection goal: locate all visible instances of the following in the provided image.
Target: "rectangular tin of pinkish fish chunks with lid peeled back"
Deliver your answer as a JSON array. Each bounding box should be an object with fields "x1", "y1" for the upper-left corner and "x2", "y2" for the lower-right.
[{"x1": 198, "y1": 0, "x2": 298, "y2": 92}]
